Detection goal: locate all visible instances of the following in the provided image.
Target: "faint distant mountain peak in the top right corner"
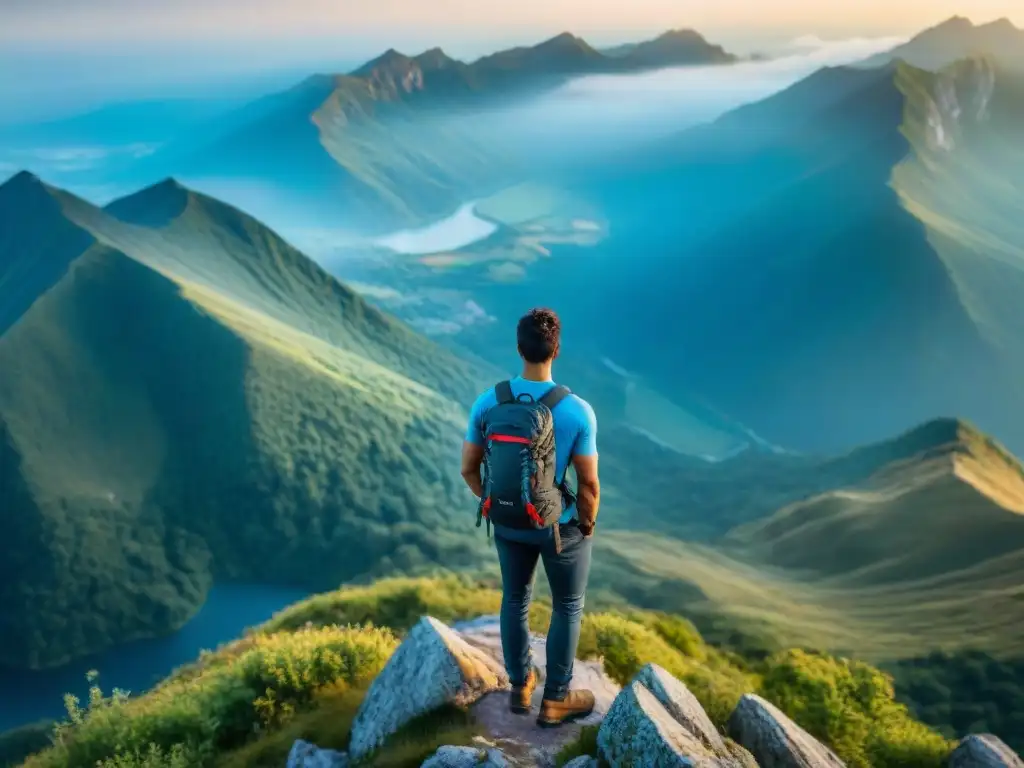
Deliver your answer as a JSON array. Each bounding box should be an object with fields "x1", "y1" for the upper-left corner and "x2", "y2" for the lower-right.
[{"x1": 861, "y1": 16, "x2": 1024, "y2": 71}]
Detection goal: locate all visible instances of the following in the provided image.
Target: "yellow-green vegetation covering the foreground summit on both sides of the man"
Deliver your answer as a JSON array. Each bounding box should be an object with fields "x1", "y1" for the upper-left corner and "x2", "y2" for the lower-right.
[{"x1": 12, "y1": 577, "x2": 951, "y2": 768}]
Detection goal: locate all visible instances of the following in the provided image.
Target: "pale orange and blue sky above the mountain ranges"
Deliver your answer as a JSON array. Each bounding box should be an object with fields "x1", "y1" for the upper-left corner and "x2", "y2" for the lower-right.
[{"x1": 0, "y1": 0, "x2": 1024, "y2": 123}]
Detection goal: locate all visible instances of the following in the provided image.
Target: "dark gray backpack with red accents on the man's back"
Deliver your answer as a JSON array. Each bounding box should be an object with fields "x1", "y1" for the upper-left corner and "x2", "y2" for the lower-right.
[{"x1": 476, "y1": 381, "x2": 575, "y2": 552}]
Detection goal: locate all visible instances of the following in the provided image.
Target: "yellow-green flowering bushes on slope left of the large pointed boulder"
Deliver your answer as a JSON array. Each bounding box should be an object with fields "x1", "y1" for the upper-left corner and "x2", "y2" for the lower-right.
[{"x1": 26, "y1": 627, "x2": 396, "y2": 768}]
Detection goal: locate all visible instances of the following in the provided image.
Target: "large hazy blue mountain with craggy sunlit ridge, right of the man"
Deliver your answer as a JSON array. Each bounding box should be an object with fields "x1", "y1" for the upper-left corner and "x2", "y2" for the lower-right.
[{"x1": 580, "y1": 58, "x2": 1024, "y2": 460}]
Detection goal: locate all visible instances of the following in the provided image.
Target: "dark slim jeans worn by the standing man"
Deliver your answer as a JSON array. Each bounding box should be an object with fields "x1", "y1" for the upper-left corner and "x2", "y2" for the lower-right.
[{"x1": 495, "y1": 520, "x2": 594, "y2": 699}]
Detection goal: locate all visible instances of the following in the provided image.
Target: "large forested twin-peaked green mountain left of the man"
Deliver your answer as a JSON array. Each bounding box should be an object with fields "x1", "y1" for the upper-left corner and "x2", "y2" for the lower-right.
[{"x1": 0, "y1": 174, "x2": 493, "y2": 667}]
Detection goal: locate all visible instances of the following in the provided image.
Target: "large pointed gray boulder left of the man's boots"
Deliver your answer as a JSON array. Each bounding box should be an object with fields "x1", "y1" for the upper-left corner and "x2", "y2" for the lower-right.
[{"x1": 349, "y1": 616, "x2": 509, "y2": 759}]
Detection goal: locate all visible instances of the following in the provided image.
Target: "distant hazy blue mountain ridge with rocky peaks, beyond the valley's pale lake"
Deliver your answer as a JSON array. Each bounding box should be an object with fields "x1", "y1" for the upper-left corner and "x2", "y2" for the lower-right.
[{"x1": 148, "y1": 33, "x2": 735, "y2": 231}]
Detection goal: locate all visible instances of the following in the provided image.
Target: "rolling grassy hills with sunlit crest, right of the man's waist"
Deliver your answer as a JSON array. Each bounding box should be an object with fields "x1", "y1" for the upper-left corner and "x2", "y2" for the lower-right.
[{"x1": 604, "y1": 420, "x2": 1024, "y2": 663}]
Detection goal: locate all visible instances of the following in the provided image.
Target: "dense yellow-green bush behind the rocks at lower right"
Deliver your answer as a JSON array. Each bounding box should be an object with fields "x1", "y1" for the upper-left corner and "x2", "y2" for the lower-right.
[{"x1": 762, "y1": 650, "x2": 952, "y2": 768}]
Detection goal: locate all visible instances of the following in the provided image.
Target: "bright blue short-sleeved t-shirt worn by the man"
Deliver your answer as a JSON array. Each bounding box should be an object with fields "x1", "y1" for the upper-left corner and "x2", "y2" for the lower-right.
[{"x1": 466, "y1": 376, "x2": 597, "y2": 523}]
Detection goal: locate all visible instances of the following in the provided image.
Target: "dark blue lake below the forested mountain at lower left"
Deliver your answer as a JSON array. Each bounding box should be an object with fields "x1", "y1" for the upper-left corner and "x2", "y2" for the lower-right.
[{"x1": 0, "y1": 585, "x2": 308, "y2": 731}]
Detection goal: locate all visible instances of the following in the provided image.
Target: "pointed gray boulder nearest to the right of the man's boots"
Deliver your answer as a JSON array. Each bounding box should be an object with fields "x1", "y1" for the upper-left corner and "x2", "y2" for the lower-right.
[{"x1": 597, "y1": 681, "x2": 744, "y2": 768}]
